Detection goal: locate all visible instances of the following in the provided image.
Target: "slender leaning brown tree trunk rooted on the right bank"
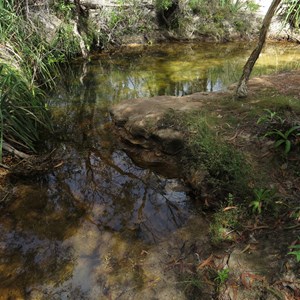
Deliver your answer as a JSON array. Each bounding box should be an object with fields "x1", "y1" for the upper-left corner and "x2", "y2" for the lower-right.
[{"x1": 235, "y1": 0, "x2": 281, "y2": 98}]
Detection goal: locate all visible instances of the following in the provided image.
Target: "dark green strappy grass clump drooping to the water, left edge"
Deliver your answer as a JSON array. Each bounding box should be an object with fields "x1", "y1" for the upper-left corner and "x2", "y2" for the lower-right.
[{"x1": 0, "y1": 65, "x2": 51, "y2": 156}]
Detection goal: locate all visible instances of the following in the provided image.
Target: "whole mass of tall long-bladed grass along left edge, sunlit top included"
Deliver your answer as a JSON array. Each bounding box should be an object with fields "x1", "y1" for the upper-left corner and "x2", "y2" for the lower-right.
[{"x1": 0, "y1": 0, "x2": 60, "y2": 160}]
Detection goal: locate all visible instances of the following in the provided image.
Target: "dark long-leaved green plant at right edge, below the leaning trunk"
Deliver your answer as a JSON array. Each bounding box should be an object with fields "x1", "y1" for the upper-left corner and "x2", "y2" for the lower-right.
[{"x1": 265, "y1": 125, "x2": 300, "y2": 154}]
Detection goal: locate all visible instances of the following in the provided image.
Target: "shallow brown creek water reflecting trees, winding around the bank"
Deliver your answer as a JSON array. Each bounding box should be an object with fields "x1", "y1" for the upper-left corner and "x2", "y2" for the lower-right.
[{"x1": 0, "y1": 44, "x2": 300, "y2": 300}]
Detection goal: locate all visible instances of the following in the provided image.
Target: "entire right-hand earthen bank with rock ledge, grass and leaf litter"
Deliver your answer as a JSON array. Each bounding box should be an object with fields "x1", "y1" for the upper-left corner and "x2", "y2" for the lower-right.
[{"x1": 112, "y1": 72, "x2": 300, "y2": 299}]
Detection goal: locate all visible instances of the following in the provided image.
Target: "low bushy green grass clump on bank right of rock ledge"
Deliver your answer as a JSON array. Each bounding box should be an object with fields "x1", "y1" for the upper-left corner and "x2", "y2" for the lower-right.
[{"x1": 183, "y1": 113, "x2": 250, "y2": 199}]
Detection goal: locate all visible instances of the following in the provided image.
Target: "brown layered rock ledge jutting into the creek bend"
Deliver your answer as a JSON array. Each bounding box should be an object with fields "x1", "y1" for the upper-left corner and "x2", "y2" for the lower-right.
[{"x1": 111, "y1": 93, "x2": 218, "y2": 177}]
